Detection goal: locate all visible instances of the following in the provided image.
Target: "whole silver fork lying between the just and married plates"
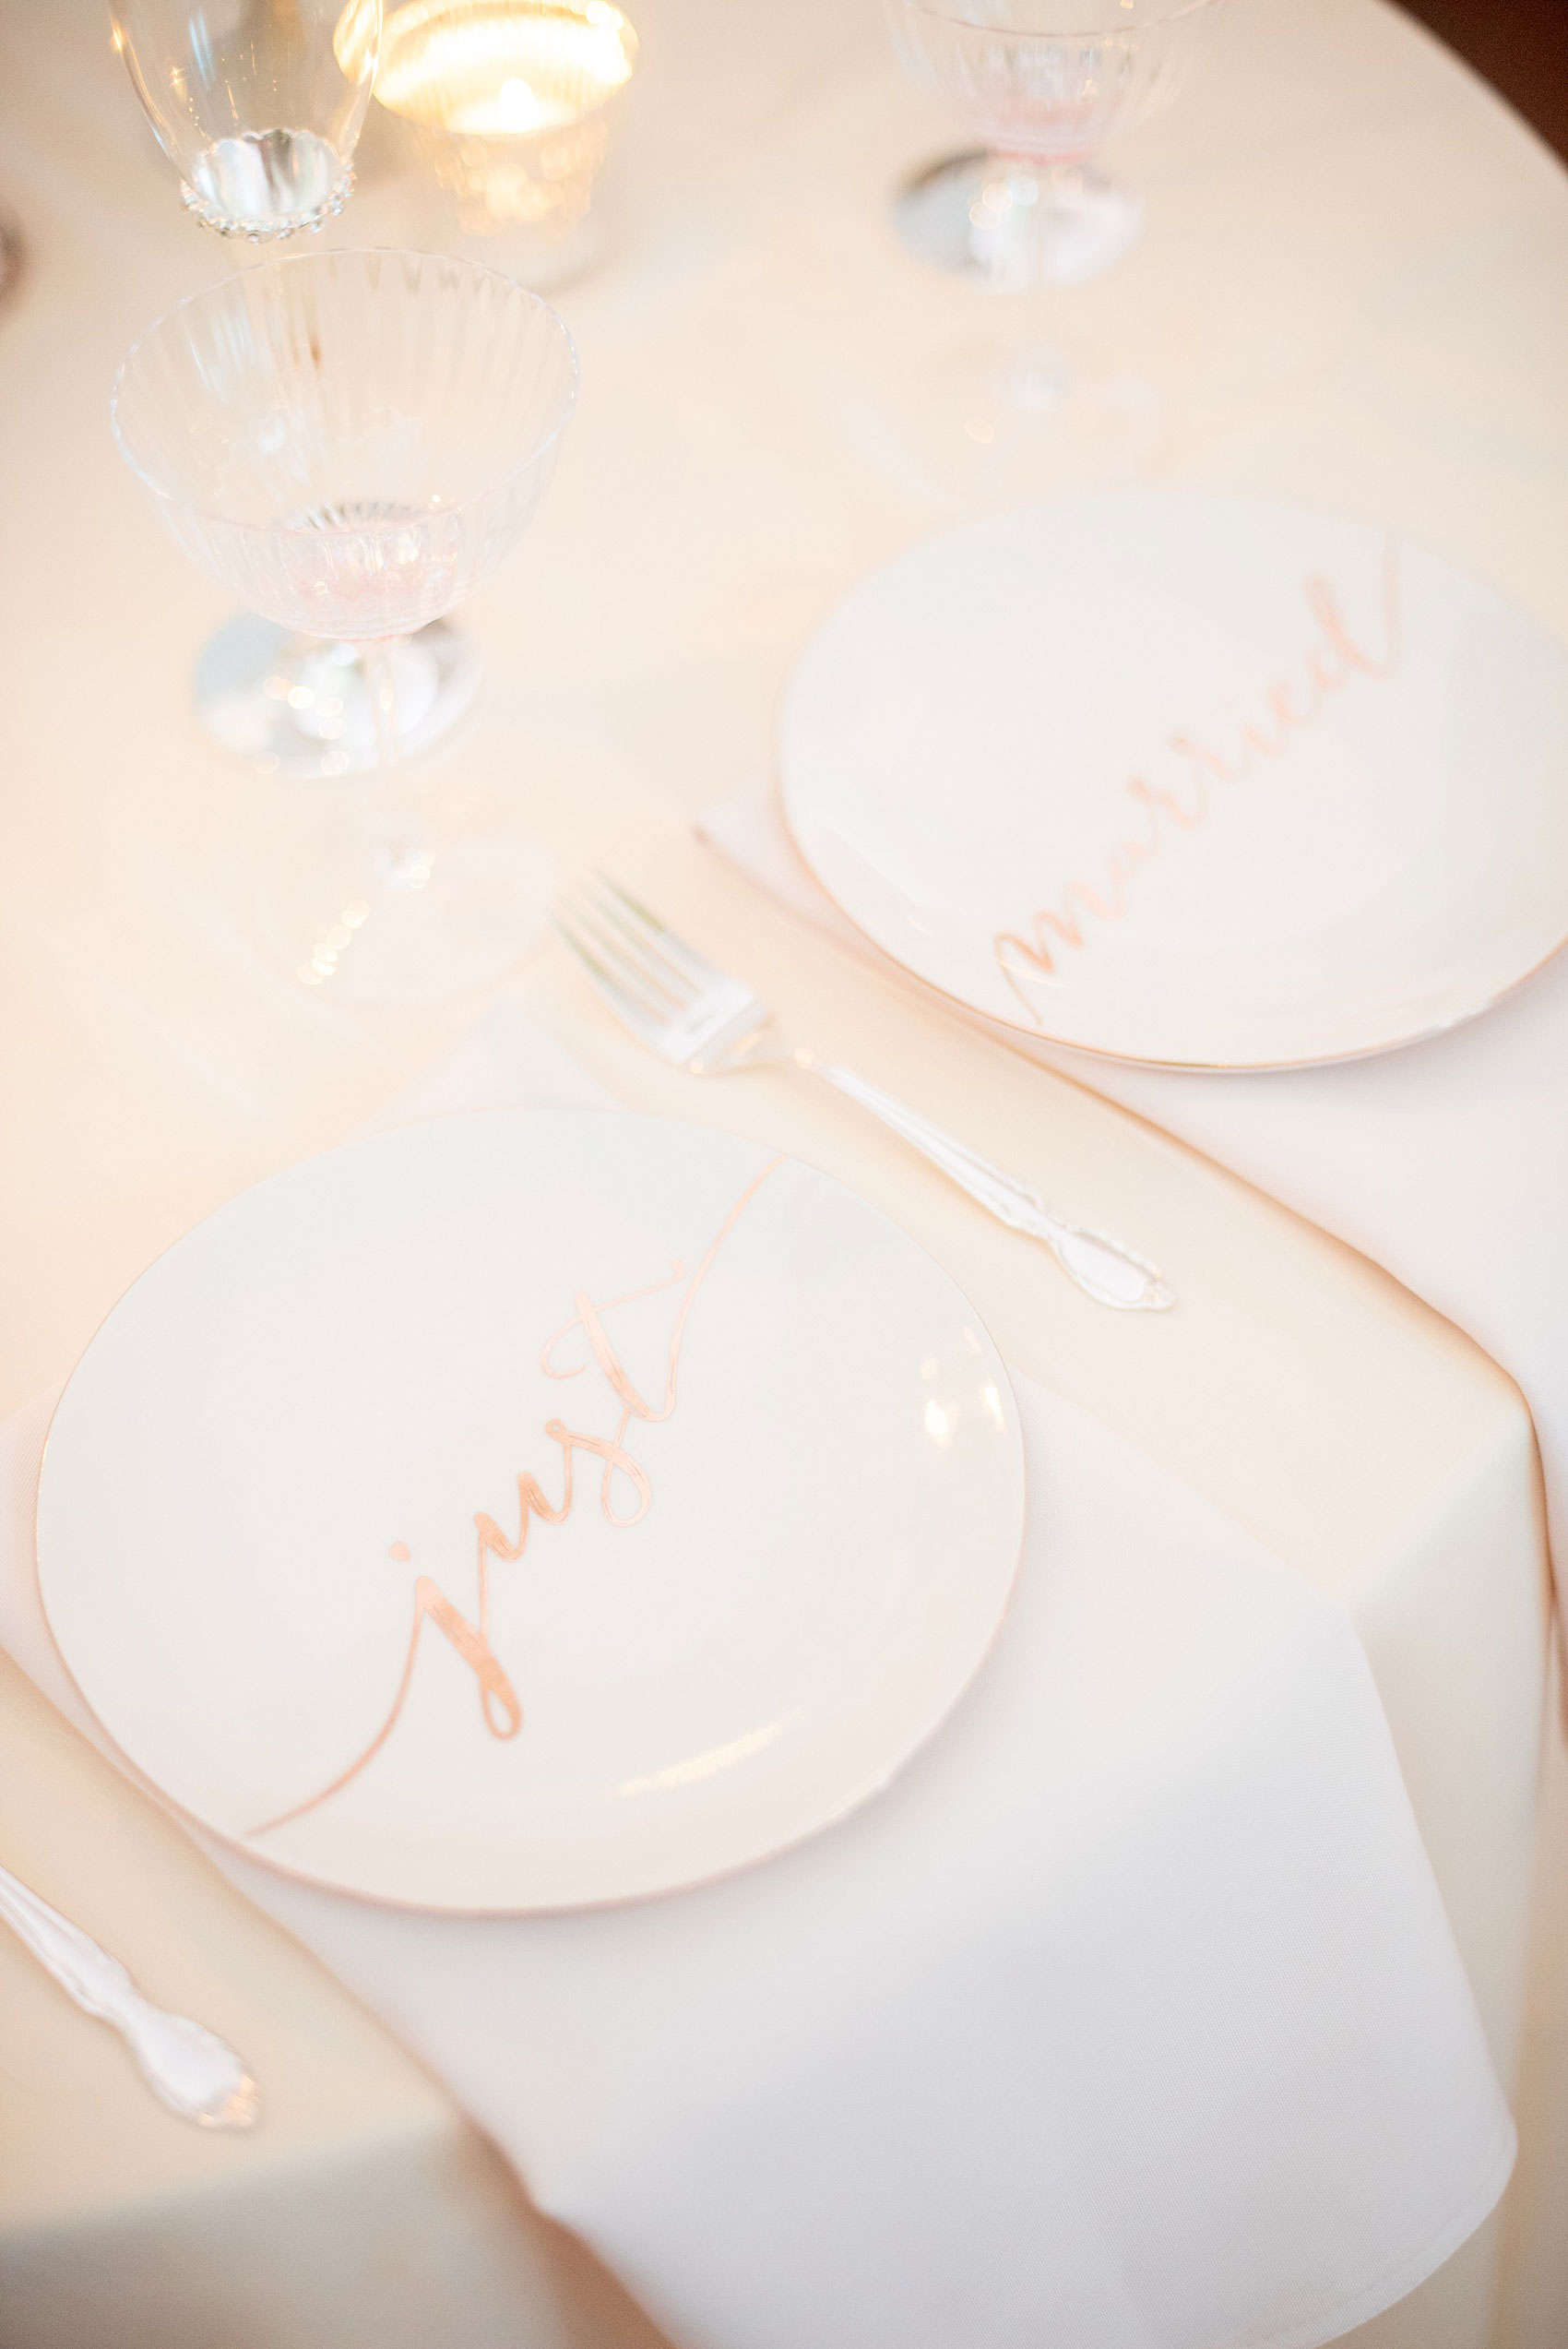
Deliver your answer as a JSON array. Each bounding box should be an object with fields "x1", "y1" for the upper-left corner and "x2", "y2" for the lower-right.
[{"x1": 556, "y1": 874, "x2": 1176, "y2": 1313}]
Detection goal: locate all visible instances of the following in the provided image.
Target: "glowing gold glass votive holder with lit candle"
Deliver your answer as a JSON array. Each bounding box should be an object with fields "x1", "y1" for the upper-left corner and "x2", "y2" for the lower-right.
[{"x1": 375, "y1": 0, "x2": 636, "y2": 280}]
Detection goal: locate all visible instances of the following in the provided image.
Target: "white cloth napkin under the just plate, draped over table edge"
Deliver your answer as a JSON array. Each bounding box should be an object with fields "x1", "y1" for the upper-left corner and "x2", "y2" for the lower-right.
[{"x1": 0, "y1": 1015, "x2": 1514, "y2": 2349}]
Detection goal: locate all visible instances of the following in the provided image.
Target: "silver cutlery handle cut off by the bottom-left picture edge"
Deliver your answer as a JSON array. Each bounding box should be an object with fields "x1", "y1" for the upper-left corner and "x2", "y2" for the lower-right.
[{"x1": 0, "y1": 1867, "x2": 260, "y2": 2128}]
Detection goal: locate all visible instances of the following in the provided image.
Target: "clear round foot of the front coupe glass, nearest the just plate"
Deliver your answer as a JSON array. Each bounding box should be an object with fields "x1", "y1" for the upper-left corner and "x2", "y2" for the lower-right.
[{"x1": 255, "y1": 822, "x2": 554, "y2": 1010}]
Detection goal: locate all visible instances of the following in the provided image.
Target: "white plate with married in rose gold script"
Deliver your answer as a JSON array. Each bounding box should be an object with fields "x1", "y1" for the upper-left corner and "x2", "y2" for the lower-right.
[{"x1": 779, "y1": 489, "x2": 1568, "y2": 1068}]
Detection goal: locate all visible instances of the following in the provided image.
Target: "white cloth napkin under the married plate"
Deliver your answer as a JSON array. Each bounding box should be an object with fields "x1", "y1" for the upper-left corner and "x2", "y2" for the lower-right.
[{"x1": 699, "y1": 780, "x2": 1568, "y2": 1606}]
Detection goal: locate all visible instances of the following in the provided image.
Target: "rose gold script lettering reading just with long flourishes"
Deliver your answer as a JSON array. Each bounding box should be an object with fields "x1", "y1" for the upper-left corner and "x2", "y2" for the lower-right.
[{"x1": 251, "y1": 1158, "x2": 781, "y2": 1834}]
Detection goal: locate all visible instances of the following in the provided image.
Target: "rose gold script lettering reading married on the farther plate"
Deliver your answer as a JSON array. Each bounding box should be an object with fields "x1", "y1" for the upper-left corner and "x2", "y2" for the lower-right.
[{"x1": 991, "y1": 538, "x2": 1401, "y2": 1024}]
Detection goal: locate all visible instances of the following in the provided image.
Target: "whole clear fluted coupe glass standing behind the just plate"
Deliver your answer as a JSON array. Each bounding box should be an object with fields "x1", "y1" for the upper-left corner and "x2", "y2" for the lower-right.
[{"x1": 113, "y1": 251, "x2": 577, "y2": 1006}]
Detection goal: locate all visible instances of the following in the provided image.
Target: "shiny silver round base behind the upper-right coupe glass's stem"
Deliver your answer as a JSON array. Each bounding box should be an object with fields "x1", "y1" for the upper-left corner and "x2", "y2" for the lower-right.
[{"x1": 892, "y1": 152, "x2": 1143, "y2": 293}]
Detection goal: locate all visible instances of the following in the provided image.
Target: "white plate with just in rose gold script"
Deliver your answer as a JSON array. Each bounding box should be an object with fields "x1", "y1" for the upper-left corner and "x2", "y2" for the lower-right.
[{"x1": 38, "y1": 1111, "x2": 1024, "y2": 1912}]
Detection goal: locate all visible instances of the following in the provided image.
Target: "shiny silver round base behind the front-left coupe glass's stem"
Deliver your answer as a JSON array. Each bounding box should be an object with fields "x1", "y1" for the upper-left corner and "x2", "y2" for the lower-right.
[{"x1": 195, "y1": 614, "x2": 479, "y2": 782}]
